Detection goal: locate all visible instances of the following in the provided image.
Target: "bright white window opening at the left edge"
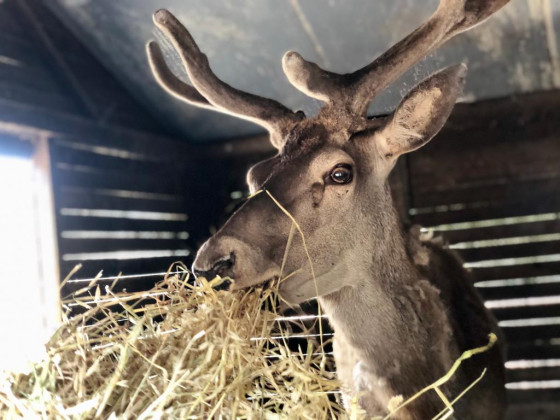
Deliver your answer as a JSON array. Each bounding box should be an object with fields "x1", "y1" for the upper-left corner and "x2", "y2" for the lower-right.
[{"x1": 0, "y1": 141, "x2": 59, "y2": 370}]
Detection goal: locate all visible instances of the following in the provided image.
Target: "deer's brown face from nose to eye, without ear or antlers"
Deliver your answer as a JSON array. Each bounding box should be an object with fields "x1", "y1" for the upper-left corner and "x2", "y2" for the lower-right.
[{"x1": 194, "y1": 121, "x2": 376, "y2": 303}]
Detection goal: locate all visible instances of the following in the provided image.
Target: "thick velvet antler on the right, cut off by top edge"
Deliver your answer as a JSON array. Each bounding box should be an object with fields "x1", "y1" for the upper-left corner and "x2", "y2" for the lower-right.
[{"x1": 282, "y1": 0, "x2": 509, "y2": 115}]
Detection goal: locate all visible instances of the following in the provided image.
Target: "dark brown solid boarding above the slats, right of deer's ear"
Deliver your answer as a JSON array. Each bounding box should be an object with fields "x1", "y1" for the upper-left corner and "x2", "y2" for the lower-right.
[{"x1": 410, "y1": 90, "x2": 560, "y2": 207}]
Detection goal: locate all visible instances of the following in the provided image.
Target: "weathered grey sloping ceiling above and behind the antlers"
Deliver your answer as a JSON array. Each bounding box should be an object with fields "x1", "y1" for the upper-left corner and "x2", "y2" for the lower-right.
[{"x1": 49, "y1": 0, "x2": 560, "y2": 141}]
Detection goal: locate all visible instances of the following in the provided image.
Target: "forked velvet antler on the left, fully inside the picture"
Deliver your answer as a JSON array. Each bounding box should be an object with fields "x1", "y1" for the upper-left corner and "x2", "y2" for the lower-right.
[{"x1": 147, "y1": 9, "x2": 304, "y2": 148}]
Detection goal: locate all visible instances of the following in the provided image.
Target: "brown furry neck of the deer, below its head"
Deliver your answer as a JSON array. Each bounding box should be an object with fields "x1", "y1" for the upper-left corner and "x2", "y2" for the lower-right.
[{"x1": 319, "y1": 200, "x2": 458, "y2": 411}]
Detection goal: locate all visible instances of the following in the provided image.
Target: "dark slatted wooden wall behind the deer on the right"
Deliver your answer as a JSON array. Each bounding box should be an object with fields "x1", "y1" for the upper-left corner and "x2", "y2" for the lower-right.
[{"x1": 408, "y1": 91, "x2": 560, "y2": 418}]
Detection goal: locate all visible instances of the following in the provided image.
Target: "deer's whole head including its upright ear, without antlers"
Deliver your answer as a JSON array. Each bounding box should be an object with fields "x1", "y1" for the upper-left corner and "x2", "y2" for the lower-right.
[{"x1": 193, "y1": 66, "x2": 465, "y2": 303}]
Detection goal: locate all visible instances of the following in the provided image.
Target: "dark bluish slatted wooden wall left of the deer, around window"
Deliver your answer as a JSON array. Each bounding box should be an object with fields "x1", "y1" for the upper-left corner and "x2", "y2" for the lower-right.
[{"x1": 0, "y1": 0, "x2": 233, "y2": 291}]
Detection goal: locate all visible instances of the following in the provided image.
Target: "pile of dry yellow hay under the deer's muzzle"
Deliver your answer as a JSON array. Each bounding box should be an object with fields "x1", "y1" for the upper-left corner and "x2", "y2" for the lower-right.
[{"x1": 0, "y1": 268, "x2": 344, "y2": 419}]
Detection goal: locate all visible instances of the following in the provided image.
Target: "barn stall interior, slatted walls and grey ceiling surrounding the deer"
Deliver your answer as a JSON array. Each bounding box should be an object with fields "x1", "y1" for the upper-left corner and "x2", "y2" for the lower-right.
[{"x1": 0, "y1": 0, "x2": 560, "y2": 418}]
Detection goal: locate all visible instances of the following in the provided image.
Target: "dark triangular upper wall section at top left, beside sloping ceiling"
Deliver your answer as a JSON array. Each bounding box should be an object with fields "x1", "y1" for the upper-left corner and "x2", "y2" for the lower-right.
[{"x1": 0, "y1": 0, "x2": 165, "y2": 133}]
